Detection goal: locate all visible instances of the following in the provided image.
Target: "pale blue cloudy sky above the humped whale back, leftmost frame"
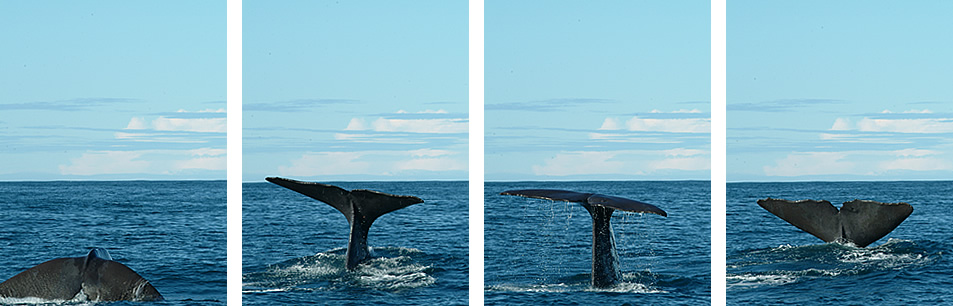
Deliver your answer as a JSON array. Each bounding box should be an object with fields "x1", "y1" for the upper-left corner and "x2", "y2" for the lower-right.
[{"x1": 0, "y1": 1, "x2": 226, "y2": 181}]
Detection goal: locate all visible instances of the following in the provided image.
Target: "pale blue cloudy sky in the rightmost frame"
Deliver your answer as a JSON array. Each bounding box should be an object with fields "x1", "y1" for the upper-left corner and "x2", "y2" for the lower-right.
[{"x1": 726, "y1": 1, "x2": 953, "y2": 182}]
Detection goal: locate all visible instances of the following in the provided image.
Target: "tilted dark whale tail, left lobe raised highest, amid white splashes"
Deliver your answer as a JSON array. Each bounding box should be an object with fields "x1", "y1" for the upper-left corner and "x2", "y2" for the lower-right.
[{"x1": 265, "y1": 177, "x2": 424, "y2": 270}]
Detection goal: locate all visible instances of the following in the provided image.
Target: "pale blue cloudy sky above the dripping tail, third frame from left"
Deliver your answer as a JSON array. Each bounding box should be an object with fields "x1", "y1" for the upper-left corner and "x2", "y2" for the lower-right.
[{"x1": 484, "y1": 1, "x2": 711, "y2": 181}]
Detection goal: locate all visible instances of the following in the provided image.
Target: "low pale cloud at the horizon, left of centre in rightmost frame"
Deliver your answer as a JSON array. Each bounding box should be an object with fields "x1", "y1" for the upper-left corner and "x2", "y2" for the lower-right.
[{"x1": 764, "y1": 152, "x2": 854, "y2": 176}]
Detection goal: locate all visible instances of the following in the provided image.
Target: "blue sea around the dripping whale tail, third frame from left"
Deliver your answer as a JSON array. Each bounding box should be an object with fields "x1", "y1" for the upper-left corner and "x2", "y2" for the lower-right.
[{"x1": 483, "y1": 181, "x2": 711, "y2": 305}]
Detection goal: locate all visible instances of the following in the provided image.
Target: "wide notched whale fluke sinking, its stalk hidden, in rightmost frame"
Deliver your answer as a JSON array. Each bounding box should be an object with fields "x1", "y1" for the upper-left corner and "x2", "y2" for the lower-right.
[{"x1": 758, "y1": 198, "x2": 913, "y2": 247}]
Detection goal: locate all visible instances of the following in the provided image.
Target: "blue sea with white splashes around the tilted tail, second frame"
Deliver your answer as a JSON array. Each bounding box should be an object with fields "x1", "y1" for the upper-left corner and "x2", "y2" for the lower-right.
[{"x1": 242, "y1": 182, "x2": 469, "y2": 305}]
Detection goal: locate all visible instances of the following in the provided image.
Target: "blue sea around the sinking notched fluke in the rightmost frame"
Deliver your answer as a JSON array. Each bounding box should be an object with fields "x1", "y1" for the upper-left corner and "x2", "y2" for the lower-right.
[{"x1": 726, "y1": 181, "x2": 953, "y2": 305}]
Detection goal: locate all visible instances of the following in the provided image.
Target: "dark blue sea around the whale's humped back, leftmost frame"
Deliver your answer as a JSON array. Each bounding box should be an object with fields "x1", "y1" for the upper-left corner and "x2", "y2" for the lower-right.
[{"x1": 0, "y1": 181, "x2": 227, "y2": 305}]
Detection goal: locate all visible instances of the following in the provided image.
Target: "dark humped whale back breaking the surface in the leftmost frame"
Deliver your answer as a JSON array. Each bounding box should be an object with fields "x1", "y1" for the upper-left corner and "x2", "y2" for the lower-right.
[{"x1": 0, "y1": 248, "x2": 163, "y2": 301}]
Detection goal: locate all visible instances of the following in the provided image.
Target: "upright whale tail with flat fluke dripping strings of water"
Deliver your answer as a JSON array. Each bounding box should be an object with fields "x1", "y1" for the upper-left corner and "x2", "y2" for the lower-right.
[{"x1": 500, "y1": 189, "x2": 668, "y2": 288}]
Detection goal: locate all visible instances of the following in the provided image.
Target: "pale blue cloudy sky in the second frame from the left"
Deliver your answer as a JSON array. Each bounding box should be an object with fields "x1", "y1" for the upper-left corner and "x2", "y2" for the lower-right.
[{"x1": 242, "y1": 1, "x2": 469, "y2": 182}]
